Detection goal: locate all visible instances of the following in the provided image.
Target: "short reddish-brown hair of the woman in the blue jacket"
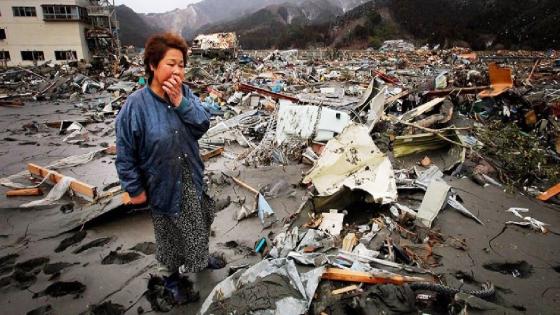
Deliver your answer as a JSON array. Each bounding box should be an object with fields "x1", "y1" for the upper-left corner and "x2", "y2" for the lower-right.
[{"x1": 144, "y1": 33, "x2": 188, "y2": 79}]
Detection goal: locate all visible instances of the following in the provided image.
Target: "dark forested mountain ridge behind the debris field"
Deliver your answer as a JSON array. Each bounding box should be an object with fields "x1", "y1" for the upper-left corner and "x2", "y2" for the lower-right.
[{"x1": 119, "y1": 0, "x2": 560, "y2": 50}]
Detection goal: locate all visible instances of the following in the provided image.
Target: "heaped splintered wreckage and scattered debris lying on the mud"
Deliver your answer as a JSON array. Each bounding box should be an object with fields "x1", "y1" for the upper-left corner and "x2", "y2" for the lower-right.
[{"x1": 0, "y1": 42, "x2": 560, "y2": 314}]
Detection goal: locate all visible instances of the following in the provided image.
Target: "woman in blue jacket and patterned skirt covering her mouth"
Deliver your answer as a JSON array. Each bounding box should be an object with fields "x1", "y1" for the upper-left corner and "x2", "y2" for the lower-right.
[{"x1": 116, "y1": 33, "x2": 219, "y2": 273}]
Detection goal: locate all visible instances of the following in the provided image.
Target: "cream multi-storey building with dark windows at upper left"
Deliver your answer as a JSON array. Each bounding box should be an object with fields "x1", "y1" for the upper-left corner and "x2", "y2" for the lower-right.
[{"x1": 0, "y1": 0, "x2": 118, "y2": 66}]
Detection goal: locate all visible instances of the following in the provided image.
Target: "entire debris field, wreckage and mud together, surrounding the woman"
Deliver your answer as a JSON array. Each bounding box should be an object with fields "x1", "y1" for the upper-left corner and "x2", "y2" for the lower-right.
[{"x1": 0, "y1": 45, "x2": 560, "y2": 314}]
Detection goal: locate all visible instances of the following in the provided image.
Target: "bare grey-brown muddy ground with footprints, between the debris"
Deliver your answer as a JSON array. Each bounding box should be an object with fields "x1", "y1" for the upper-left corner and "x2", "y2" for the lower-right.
[{"x1": 0, "y1": 102, "x2": 560, "y2": 314}]
